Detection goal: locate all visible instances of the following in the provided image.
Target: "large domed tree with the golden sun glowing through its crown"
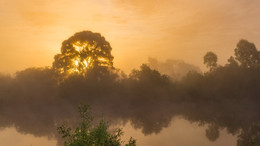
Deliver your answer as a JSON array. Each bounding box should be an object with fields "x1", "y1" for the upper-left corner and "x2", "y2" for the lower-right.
[{"x1": 53, "y1": 31, "x2": 114, "y2": 74}]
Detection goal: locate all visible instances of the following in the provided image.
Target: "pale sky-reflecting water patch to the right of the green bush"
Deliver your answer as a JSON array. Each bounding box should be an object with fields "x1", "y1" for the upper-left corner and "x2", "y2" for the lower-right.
[{"x1": 121, "y1": 118, "x2": 236, "y2": 146}]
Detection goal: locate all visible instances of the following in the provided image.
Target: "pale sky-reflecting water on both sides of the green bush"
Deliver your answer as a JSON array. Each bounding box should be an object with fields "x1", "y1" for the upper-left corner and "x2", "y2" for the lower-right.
[{"x1": 0, "y1": 118, "x2": 236, "y2": 146}]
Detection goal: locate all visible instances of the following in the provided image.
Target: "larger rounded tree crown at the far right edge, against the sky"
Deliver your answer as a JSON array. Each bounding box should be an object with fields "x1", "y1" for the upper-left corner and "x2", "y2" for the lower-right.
[{"x1": 235, "y1": 39, "x2": 260, "y2": 68}]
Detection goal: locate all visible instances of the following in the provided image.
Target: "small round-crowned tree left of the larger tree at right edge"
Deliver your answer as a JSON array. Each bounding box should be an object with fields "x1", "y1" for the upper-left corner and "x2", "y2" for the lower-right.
[{"x1": 204, "y1": 52, "x2": 218, "y2": 70}]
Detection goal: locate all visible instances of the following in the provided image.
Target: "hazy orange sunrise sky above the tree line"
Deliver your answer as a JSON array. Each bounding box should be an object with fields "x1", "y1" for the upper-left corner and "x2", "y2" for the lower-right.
[{"x1": 0, "y1": 0, "x2": 260, "y2": 73}]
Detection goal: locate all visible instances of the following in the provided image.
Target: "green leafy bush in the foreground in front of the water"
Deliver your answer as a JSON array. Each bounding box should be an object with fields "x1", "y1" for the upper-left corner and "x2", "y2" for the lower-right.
[{"x1": 57, "y1": 105, "x2": 136, "y2": 146}]
